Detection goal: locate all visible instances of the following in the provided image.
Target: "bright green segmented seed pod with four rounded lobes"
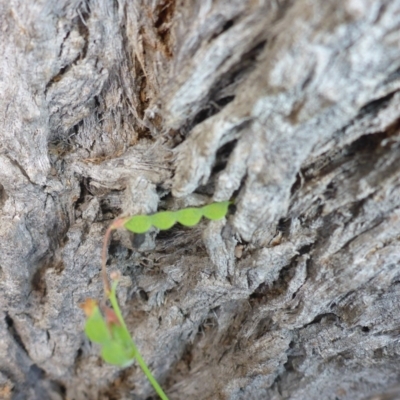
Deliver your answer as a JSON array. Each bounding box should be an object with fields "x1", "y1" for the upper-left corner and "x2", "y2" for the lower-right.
[{"x1": 124, "y1": 201, "x2": 232, "y2": 233}]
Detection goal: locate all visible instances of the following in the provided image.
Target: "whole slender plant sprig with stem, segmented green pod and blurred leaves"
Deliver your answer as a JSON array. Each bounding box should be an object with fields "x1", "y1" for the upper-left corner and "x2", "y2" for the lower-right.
[{"x1": 81, "y1": 201, "x2": 231, "y2": 400}]
